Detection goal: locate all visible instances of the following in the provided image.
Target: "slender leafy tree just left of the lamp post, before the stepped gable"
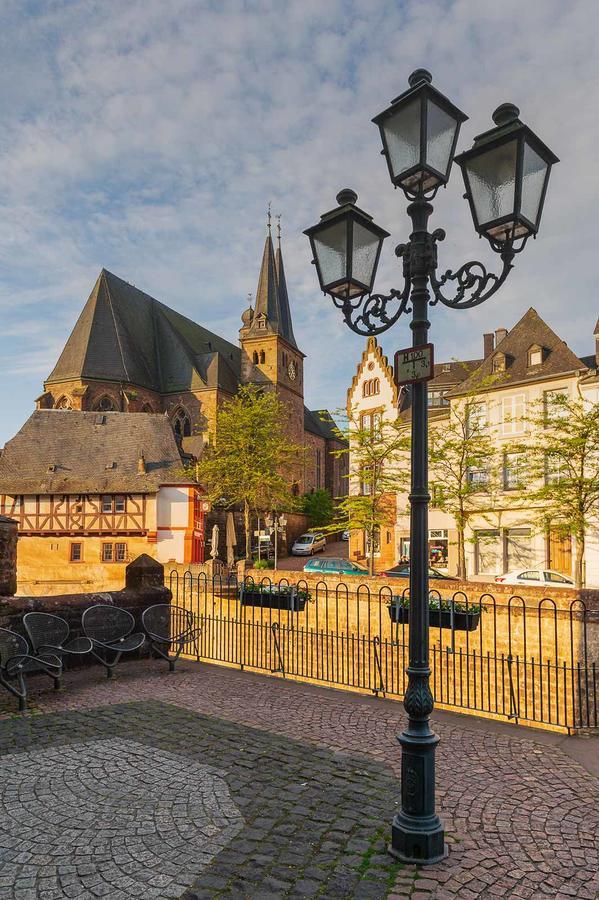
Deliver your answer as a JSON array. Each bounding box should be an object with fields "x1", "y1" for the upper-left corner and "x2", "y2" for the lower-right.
[{"x1": 326, "y1": 409, "x2": 410, "y2": 575}]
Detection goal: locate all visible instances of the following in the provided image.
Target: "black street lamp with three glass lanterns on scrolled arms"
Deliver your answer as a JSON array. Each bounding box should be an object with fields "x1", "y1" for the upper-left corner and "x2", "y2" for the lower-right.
[{"x1": 305, "y1": 69, "x2": 558, "y2": 864}]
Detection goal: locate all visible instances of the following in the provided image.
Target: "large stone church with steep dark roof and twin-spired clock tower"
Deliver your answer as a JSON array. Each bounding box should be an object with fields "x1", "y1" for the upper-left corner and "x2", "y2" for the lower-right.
[{"x1": 37, "y1": 225, "x2": 346, "y2": 496}]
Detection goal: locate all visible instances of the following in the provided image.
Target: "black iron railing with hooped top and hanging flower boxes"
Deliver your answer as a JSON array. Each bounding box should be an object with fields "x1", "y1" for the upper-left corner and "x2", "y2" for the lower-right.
[{"x1": 169, "y1": 571, "x2": 599, "y2": 730}]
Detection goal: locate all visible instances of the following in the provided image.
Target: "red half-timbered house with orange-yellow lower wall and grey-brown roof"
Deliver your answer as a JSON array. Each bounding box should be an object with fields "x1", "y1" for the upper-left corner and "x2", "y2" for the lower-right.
[{"x1": 0, "y1": 409, "x2": 204, "y2": 594}]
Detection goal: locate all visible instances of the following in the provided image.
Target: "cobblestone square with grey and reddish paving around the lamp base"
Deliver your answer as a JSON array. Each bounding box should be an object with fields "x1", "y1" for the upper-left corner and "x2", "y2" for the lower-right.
[{"x1": 0, "y1": 661, "x2": 599, "y2": 900}]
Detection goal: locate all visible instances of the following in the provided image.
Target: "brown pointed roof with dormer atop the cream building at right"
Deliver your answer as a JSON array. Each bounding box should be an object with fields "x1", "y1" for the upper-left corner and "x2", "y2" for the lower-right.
[{"x1": 448, "y1": 307, "x2": 585, "y2": 397}]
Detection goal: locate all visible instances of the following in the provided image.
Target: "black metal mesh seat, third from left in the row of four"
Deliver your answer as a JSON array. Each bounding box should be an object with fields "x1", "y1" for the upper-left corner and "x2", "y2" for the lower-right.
[{"x1": 81, "y1": 603, "x2": 146, "y2": 678}]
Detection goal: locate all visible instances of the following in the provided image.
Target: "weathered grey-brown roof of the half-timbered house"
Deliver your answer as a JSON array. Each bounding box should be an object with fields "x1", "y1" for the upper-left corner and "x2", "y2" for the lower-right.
[{"x1": 0, "y1": 409, "x2": 190, "y2": 494}]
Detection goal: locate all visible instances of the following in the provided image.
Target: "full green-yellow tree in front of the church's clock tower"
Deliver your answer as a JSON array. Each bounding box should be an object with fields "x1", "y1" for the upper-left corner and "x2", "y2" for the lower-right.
[{"x1": 195, "y1": 385, "x2": 304, "y2": 559}]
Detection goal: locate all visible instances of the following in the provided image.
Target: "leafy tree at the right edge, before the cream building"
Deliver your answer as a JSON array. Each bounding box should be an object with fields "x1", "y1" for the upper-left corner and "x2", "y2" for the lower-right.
[{"x1": 514, "y1": 385, "x2": 599, "y2": 588}]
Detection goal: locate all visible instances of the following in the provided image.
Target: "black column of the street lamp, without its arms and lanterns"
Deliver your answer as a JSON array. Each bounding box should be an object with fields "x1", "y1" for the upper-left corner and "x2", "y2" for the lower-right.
[{"x1": 391, "y1": 199, "x2": 446, "y2": 863}]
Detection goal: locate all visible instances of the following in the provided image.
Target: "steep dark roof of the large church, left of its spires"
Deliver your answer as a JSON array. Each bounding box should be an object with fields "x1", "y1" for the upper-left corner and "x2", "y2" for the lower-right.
[{"x1": 46, "y1": 269, "x2": 241, "y2": 393}]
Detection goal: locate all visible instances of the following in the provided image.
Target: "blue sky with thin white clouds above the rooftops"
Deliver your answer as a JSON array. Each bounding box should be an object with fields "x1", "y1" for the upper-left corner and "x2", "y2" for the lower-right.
[{"x1": 0, "y1": 0, "x2": 599, "y2": 445}]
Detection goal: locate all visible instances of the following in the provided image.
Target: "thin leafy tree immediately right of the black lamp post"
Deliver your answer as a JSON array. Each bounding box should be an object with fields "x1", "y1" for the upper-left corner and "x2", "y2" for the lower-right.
[{"x1": 429, "y1": 379, "x2": 497, "y2": 578}]
